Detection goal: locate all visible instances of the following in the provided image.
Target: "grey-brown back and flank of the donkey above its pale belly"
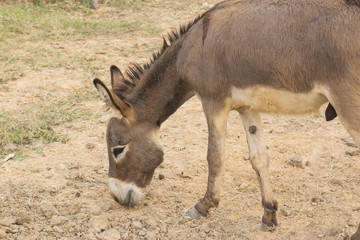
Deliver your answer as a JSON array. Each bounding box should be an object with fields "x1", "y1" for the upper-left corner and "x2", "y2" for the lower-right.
[{"x1": 178, "y1": 0, "x2": 360, "y2": 106}]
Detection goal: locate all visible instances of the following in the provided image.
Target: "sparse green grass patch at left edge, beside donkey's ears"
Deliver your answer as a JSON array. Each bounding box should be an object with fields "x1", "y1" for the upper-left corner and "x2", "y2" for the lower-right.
[{"x1": 0, "y1": 89, "x2": 102, "y2": 159}]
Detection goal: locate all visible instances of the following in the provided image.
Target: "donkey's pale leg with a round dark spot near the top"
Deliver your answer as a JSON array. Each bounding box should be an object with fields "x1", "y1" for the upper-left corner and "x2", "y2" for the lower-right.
[{"x1": 239, "y1": 110, "x2": 278, "y2": 227}]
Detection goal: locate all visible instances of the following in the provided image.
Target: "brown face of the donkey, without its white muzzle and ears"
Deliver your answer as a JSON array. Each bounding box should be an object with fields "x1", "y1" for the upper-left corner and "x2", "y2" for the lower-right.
[{"x1": 106, "y1": 118, "x2": 163, "y2": 187}]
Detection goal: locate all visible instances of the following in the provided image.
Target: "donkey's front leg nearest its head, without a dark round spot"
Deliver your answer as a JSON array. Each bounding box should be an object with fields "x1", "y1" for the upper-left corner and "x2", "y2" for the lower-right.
[{"x1": 195, "y1": 99, "x2": 231, "y2": 216}]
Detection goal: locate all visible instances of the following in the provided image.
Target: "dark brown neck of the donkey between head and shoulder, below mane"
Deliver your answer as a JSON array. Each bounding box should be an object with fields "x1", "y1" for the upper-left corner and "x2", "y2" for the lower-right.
[{"x1": 131, "y1": 39, "x2": 194, "y2": 125}]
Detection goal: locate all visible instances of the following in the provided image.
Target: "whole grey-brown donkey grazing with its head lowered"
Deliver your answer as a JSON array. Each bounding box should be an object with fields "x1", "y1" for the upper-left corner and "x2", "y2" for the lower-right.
[{"x1": 94, "y1": 0, "x2": 360, "y2": 236}]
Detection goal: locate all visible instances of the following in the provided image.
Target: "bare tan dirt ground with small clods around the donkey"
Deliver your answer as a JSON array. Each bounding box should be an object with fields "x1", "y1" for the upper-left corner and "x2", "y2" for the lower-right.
[{"x1": 0, "y1": 1, "x2": 360, "y2": 240}]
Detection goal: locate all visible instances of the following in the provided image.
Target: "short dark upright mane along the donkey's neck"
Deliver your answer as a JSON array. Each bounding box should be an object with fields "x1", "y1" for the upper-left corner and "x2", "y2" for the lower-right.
[{"x1": 113, "y1": 14, "x2": 204, "y2": 95}]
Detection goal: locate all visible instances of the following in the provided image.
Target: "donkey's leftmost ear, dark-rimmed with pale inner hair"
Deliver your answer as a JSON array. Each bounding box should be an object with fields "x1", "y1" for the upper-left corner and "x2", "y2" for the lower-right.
[{"x1": 93, "y1": 78, "x2": 131, "y2": 118}]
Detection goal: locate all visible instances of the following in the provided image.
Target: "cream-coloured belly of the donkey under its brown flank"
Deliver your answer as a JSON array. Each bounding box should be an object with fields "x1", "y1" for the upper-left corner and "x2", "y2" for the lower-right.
[{"x1": 231, "y1": 86, "x2": 328, "y2": 114}]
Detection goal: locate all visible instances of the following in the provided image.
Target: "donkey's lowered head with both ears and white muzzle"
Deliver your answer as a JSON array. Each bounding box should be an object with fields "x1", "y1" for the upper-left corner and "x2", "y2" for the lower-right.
[{"x1": 94, "y1": 66, "x2": 163, "y2": 206}]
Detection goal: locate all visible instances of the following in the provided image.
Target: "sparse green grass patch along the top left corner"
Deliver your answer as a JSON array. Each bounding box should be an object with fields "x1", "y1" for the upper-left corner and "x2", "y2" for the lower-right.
[{"x1": 0, "y1": 4, "x2": 140, "y2": 41}]
